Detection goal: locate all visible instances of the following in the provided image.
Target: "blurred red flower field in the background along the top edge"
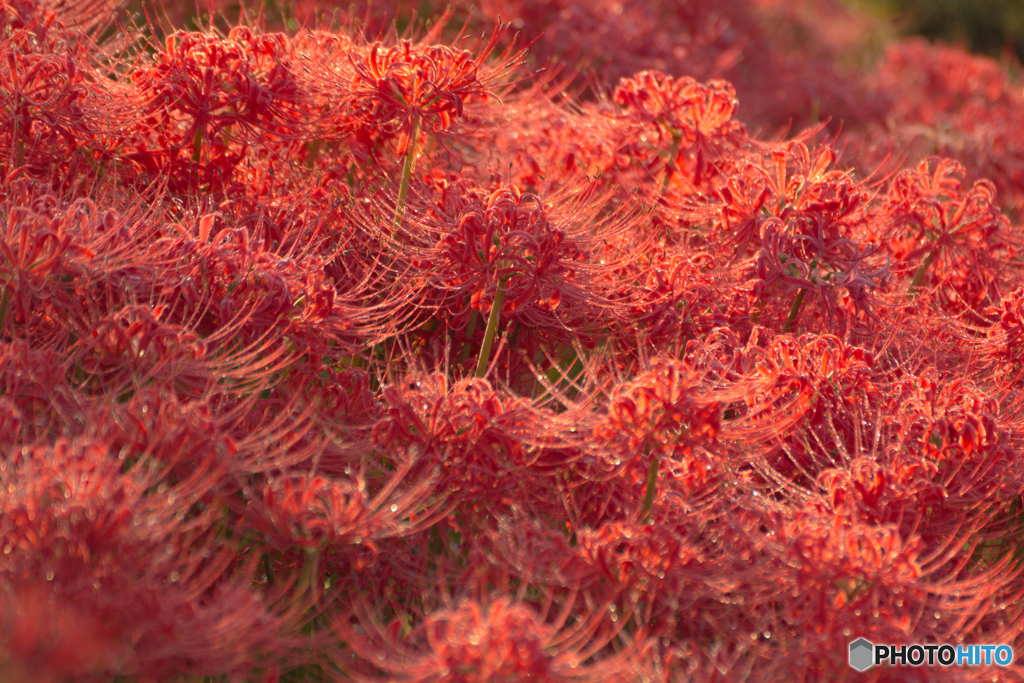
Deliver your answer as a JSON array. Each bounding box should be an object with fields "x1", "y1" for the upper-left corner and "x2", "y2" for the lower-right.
[{"x1": 119, "y1": 0, "x2": 1024, "y2": 215}]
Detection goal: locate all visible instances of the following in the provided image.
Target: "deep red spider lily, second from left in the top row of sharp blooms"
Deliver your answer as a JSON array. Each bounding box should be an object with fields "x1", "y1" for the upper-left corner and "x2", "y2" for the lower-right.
[{"x1": 113, "y1": 26, "x2": 311, "y2": 198}]
